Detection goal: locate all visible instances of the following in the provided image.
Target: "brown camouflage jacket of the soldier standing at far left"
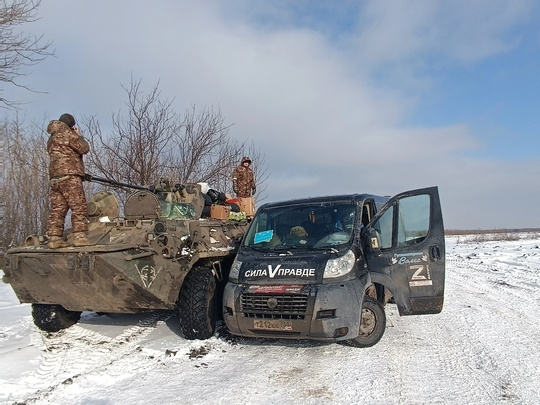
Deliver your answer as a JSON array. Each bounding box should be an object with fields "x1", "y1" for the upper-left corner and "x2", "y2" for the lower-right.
[{"x1": 47, "y1": 120, "x2": 90, "y2": 179}]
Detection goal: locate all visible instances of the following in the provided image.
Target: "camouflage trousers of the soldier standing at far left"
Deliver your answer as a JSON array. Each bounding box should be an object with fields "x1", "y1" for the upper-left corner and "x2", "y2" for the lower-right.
[{"x1": 47, "y1": 176, "x2": 88, "y2": 237}]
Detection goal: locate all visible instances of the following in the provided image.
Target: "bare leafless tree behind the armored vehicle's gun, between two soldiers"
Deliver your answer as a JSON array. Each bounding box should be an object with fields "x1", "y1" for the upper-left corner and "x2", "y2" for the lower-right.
[{"x1": 82, "y1": 79, "x2": 265, "y2": 196}]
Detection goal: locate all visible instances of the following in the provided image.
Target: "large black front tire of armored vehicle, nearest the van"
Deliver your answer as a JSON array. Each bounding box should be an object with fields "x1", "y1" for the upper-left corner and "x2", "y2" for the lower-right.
[{"x1": 178, "y1": 267, "x2": 218, "y2": 340}]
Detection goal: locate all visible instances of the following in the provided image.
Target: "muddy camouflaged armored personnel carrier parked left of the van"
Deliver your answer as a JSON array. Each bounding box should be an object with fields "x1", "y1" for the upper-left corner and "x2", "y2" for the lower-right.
[{"x1": 3, "y1": 178, "x2": 247, "y2": 339}]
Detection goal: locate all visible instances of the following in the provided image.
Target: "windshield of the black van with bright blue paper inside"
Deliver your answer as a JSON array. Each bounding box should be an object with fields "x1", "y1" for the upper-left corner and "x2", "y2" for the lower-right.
[{"x1": 244, "y1": 201, "x2": 356, "y2": 251}]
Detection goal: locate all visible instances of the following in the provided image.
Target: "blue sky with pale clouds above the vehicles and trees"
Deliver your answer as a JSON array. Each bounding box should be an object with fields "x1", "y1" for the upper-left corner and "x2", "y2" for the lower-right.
[{"x1": 4, "y1": 0, "x2": 540, "y2": 228}]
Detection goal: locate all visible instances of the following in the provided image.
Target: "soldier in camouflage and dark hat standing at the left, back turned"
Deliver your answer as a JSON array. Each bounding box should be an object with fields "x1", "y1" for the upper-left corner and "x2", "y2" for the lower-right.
[{"x1": 47, "y1": 114, "x2": 93, "y2": 249}]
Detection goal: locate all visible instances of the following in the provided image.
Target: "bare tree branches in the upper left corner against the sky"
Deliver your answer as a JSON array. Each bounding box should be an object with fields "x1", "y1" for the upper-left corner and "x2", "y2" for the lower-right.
[{"x1": 0, "y1": 0, "x2": 53, "y2": 108}]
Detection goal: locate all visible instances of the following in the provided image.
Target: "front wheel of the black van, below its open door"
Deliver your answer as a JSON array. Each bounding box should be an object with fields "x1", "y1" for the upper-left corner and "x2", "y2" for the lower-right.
[{"x1": 347, "y1": 296, "x2": 386, "y2": 347}]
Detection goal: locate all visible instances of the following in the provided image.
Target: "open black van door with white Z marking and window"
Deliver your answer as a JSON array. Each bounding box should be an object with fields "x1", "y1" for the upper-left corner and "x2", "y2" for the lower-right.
[{"x1": 362, "y1": 187, "x2": 445, "y2": 315}]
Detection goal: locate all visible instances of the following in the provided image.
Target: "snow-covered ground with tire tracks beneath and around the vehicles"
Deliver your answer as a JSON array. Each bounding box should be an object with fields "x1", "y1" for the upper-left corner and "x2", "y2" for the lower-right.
[{"x1": 0, "y1": 234, "x2": 540, "y2": 405}]
